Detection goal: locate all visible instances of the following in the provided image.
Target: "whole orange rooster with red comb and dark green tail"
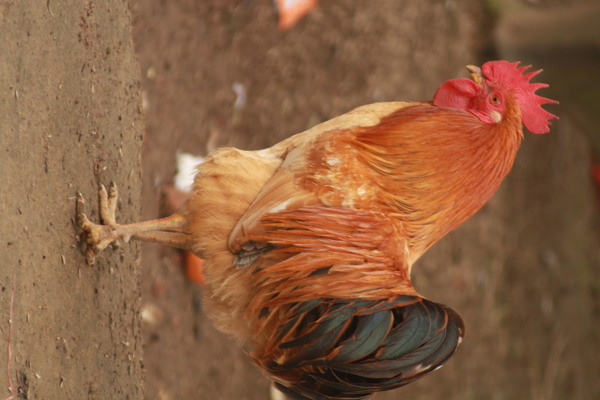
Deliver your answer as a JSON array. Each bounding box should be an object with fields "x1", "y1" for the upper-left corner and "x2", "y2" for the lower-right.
[{"x1": 77, "y1": 61, "x2": 557, "y2": 400}]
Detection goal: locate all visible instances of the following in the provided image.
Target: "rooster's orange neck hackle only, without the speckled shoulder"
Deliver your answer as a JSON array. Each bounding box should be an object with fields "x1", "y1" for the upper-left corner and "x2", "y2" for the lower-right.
[{"x1": 356, "y1": 103, "x2": 522, "y2": 265}]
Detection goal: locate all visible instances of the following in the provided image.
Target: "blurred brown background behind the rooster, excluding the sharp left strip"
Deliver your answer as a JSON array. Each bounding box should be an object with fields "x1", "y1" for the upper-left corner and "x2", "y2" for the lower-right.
[{"x1": 130, "y1": 0, "x2": 600, "y2": 400}]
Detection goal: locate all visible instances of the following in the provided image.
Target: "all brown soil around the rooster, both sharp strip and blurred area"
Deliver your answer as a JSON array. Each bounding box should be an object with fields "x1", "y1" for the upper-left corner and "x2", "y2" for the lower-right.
[{"x1": 0, "y1": 0, "x2": 600, "y2": 400}]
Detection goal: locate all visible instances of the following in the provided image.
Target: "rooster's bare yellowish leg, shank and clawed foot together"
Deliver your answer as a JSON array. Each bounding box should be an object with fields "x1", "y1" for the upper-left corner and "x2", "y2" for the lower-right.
[{"x1": 77, "y1": 184, "x2": 189, "y2": 264}]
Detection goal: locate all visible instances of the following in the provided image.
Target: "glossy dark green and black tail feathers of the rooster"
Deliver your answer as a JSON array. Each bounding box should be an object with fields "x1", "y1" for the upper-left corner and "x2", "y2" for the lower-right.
[{"x1": 265, "y1": 296, "x2": 464, "y2": 400}]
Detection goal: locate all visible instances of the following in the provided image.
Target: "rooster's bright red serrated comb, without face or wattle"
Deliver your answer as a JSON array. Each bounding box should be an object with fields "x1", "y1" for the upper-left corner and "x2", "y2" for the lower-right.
[{"x1": 481, "y1": 60, "x2": 558, "y2": 133}]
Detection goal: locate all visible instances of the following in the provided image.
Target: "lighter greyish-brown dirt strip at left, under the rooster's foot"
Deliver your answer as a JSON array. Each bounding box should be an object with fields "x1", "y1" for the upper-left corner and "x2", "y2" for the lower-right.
[{"x1": 0, "y1": 0, "x2": 143, "y2": 399}]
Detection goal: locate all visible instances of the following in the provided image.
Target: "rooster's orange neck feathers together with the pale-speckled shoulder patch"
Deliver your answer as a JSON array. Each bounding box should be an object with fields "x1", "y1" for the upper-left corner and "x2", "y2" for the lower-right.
[{"x1": 298, "y1": 103, "x2": 522, "y2": 268}]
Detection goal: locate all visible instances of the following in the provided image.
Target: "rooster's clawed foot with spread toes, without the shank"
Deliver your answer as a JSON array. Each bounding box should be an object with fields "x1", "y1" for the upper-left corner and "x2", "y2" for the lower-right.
[{"x1": 76, "y1": 183, "x2": 129, "y2": 265}]
